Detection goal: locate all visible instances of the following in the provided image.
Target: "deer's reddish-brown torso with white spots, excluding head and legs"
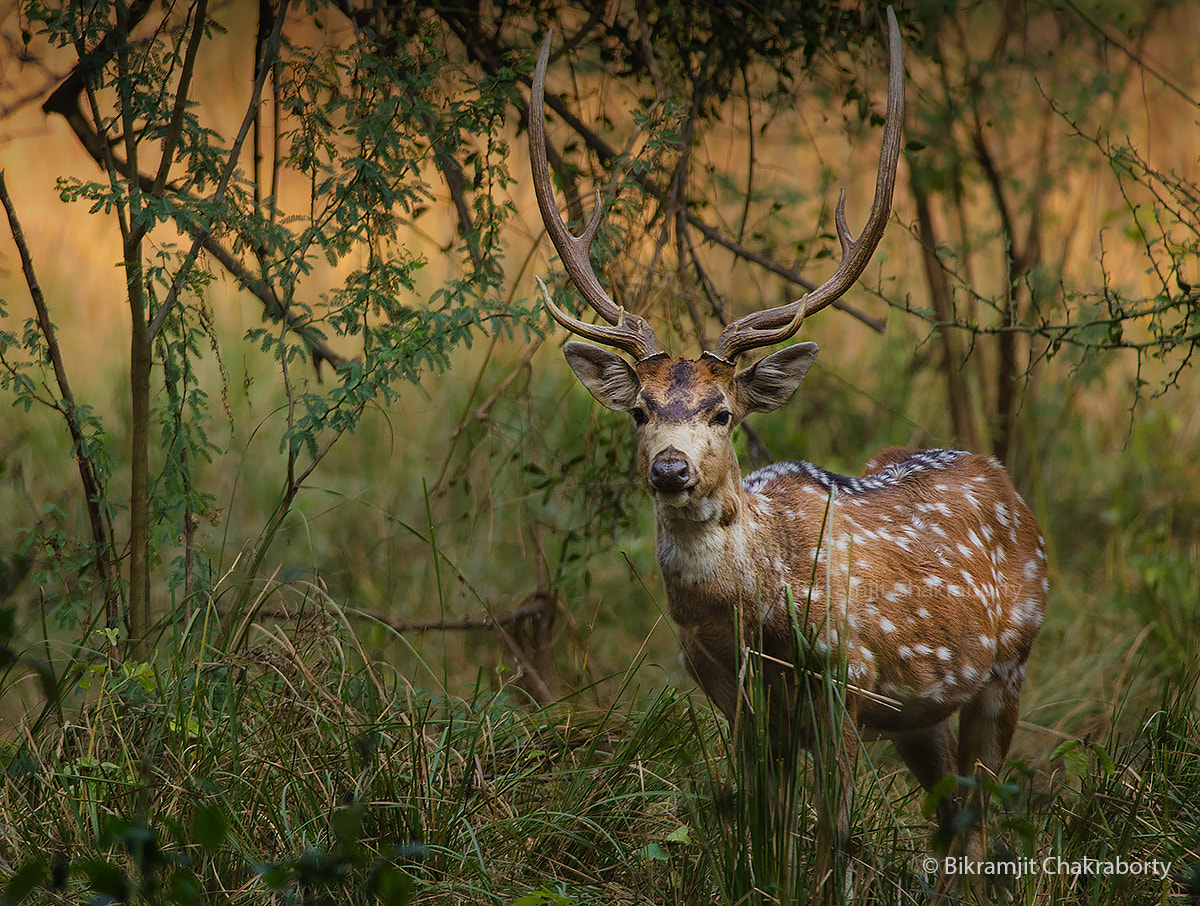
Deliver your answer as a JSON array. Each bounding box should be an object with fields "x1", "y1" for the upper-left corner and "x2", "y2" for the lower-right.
[{"x1": 659, "y1": 448, "x2": 1046, "y2": 733}]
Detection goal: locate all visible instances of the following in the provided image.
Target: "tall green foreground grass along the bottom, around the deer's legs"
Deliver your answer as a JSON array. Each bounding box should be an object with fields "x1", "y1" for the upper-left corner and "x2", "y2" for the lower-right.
[{"x1": 0, "y1": 573, "x2": 1200, "y2": 906}]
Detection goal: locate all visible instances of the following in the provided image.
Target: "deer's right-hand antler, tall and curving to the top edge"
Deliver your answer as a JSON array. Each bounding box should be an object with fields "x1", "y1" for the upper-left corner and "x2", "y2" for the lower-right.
[{"x1": 713, "y1": 6, "x2": 904, "y2": 360}]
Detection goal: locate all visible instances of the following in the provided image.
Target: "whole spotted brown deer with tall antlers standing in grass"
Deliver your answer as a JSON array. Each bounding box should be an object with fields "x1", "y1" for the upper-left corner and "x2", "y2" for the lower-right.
[{"x1": 528, "y1": 8, "x2": 1046, "y2": 892}]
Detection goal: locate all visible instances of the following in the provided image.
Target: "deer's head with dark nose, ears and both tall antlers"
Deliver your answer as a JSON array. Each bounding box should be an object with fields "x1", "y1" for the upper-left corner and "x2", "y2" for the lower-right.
[{"x1": 529, "y1": 7, "x2": 904, "y2": 520}]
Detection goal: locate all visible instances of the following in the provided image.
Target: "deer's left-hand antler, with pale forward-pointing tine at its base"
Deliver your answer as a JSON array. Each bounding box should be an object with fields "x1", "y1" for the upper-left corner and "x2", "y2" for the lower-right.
[{"x1": 529, "y1": 31, "x2": 661, "y2": 359}]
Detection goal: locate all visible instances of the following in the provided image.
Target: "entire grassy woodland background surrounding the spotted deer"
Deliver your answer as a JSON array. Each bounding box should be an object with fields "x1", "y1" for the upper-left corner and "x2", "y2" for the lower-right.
[{"x1": 0, "y1": 0, "x2": 1200, "y2": 904}]
